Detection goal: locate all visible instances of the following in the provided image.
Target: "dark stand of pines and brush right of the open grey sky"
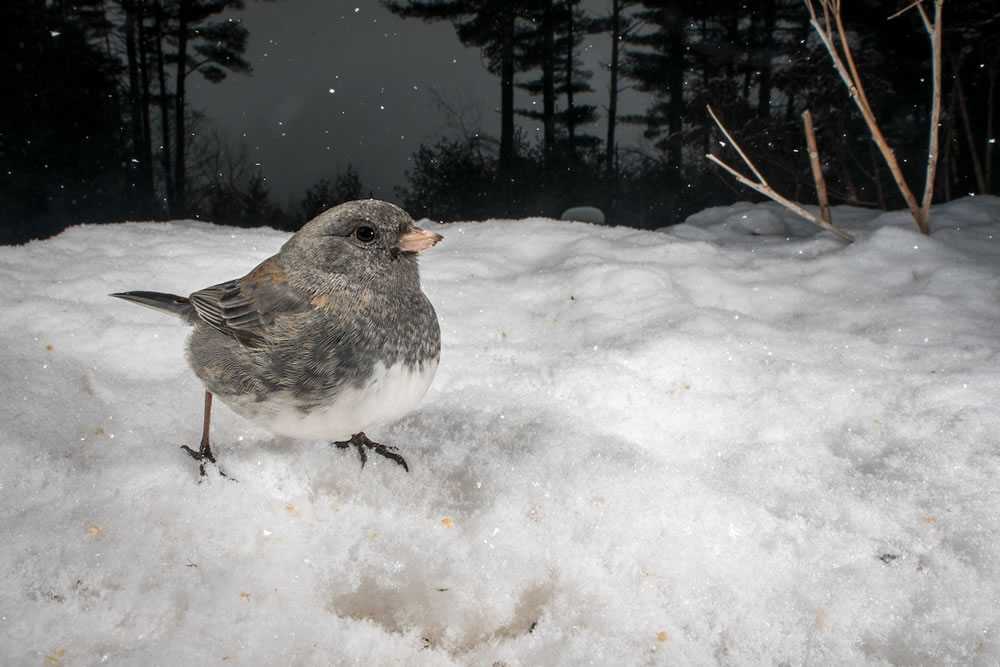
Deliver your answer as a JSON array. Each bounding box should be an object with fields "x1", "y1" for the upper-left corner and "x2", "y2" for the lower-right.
[{"x1": 386, "y1": 0, "x2": 1000, "y2": 227}]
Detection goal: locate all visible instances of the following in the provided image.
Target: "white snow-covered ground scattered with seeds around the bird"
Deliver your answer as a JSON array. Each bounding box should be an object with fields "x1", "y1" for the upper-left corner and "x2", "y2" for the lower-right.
[{"x1": 0, "y1": 197, "x2": 1000, "y2": 666}]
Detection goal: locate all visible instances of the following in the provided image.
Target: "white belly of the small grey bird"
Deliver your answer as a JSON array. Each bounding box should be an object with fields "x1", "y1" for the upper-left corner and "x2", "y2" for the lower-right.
[{"x1": 227, "y1": 361, "x2": 437, "y2": 440}]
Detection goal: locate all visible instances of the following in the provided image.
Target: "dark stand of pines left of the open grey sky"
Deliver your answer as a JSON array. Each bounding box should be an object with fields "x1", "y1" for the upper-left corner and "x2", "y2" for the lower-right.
[{"x1": 0, "y1": 0, "x2": 266, "y2": 242}]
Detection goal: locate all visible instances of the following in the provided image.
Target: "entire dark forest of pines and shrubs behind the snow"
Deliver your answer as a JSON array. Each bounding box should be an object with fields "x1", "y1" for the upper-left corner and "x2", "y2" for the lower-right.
[{"x1": 0, "y1": 0, "x2": 1000, "y2": 244}]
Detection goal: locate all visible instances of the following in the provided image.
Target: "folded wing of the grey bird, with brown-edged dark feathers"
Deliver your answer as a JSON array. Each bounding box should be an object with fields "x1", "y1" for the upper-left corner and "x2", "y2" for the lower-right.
[{"x1": 189, "y1": 260, "x2": 310, "y2": 348}]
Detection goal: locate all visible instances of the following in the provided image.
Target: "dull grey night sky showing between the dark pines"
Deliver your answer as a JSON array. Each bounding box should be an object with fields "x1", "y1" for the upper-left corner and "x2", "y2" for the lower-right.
[{"x1": 189, "y1": 0, "x2": 635, "y2": 206}]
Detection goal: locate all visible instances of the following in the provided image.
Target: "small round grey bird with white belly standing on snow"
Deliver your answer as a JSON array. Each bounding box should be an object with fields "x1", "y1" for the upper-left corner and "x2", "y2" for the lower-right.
[{"x1": 111, "y1": 200, "x2": 442, "y2": 474}]
